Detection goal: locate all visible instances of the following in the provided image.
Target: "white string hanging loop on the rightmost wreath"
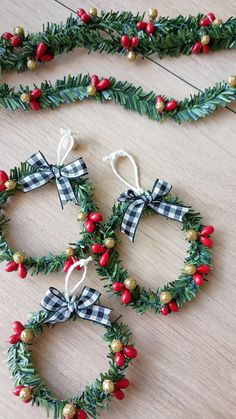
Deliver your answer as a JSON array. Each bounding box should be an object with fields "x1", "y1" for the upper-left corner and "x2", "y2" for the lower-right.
[{"x1": 103, "y1": 150, "x2": 144, "y2": 194}]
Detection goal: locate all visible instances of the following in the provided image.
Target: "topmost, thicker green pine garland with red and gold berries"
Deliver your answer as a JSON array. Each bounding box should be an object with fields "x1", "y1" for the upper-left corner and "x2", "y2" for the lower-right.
[{"x1": 0, "y1": 7, "x2": 236, "y2": 72}]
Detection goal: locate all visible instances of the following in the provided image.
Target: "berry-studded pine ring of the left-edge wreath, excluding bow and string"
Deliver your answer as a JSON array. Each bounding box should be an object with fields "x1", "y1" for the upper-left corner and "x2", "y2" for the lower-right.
[{"x1": 0, "y1": 156, "x2": 100, "y2": 278}]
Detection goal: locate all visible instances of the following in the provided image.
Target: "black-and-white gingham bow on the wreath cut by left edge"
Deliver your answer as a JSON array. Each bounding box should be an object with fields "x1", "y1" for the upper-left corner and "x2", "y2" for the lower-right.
[{"x1": 18, "y1": 151, "x2": 88, "y2": 208}]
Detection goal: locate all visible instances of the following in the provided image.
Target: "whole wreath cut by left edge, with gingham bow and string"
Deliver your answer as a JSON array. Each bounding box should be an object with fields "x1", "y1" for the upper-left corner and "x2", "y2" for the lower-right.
[{"x1": 0, "y1": 130, "x2": 101, "y2": 278}]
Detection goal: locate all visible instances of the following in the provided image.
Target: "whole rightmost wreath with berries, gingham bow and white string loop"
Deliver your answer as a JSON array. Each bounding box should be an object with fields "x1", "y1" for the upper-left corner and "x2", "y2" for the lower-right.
[{"x1": 77, "y1": 150, "x2": 214, "y2": 315}]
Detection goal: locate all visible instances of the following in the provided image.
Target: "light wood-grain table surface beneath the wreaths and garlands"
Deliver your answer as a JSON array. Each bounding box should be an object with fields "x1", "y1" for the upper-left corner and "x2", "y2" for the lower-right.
[{"x1": 0, "y1": 0, "x2": 236, "y2": 419}]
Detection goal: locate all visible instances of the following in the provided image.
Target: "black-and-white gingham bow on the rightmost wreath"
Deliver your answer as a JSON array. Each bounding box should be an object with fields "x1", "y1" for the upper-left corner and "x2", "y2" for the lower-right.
[{"x1": 118, "y1": 179, "x2": 189, "y2": 241}]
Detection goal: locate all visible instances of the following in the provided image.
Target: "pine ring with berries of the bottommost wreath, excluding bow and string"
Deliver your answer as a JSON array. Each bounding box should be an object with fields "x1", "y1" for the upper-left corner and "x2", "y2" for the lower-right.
[{"x1": 7, "y1": 310, "x2": 137, "y2": 419}]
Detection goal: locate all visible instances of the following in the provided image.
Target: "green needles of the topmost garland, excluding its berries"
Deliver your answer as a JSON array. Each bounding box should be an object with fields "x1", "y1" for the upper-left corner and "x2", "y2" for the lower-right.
[{"x1": 0, "y1": 11, "x2": 236, "y2": 72}]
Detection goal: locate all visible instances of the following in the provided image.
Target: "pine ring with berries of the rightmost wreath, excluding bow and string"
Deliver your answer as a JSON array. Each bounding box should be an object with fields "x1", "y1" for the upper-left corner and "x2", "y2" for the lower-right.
[{"x1": 77, "y1": 187, "x2": 214, "y2": 315}]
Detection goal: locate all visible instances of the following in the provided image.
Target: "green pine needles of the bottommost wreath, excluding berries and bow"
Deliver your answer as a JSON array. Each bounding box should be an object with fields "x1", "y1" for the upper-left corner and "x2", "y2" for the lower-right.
[{"x1": 7, "y1": 316, "x2": 135, "y2": 419}]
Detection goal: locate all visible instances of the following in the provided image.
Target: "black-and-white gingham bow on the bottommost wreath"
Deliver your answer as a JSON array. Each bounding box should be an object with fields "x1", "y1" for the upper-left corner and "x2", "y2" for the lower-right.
[{"x1": 41, "y1": 287, "x2": 111, "y2": 326}]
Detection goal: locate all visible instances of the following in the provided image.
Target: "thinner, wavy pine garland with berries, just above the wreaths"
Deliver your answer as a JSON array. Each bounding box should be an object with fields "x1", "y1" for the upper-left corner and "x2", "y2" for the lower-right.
[{"x1": 0, "y1": 74, "x2": 236, "y2": 123}]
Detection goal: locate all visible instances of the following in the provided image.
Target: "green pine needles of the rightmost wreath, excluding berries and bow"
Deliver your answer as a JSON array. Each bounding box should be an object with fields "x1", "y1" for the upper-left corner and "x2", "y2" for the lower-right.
[{"x1": 80, "y1": 199, "x2": 211, "y2": 314}]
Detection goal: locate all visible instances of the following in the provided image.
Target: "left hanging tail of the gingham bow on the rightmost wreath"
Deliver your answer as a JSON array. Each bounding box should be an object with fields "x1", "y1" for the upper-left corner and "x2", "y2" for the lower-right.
[{"x1": 120, "y1": 199, "x2": 145, "y2": 241}]
